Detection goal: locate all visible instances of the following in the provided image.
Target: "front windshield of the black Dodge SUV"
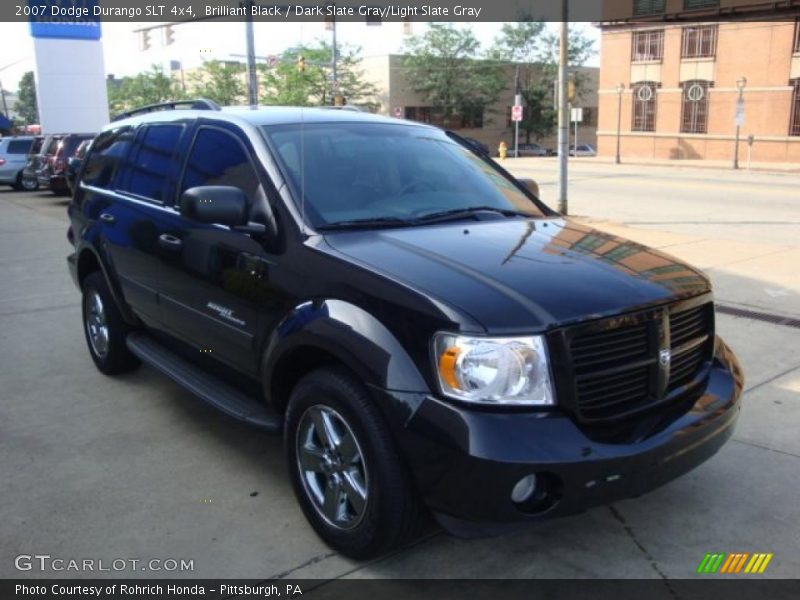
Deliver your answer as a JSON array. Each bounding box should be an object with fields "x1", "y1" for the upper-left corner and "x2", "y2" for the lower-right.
[{"x1": 264, "y1": 123, "x2": 545, "y2": 227}]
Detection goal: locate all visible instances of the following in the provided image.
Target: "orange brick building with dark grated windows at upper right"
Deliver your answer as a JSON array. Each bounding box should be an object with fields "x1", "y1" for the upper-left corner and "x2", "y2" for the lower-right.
[{"x1": 598, "y1": 0, "x2": 800, "y2": 163}]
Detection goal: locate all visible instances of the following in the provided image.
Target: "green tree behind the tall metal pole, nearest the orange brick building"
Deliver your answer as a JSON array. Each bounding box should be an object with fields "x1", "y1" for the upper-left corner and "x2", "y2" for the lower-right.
[{"x1": 490, "y1": 20, "x2": 595, "y2": 143}]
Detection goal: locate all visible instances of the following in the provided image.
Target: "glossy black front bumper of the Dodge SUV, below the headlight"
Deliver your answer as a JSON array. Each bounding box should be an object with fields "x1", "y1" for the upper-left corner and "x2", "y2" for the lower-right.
[{"x1": 390, "y1": 338, "x2": 744, "y2": 536}]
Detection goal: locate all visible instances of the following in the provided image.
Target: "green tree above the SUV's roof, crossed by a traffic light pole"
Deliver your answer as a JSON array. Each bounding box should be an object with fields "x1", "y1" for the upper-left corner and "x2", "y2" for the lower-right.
[{"x1": 258, "y1": 41, "x2": 377, "y2": 106}]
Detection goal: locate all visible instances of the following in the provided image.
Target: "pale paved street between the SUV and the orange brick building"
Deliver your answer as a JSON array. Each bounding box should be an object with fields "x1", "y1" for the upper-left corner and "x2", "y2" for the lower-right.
[{"x1": 504, "y1": 158, "x2": 800, "y2": 244}]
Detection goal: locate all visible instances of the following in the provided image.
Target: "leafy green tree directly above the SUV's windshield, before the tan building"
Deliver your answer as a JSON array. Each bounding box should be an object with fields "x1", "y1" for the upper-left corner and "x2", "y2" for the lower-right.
[{"x1": 403, "y1": 23, "x2": 508, "y2": 126}]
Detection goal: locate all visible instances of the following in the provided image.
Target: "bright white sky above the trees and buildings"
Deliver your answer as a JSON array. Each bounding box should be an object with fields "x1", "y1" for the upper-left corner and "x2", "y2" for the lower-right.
[{"x1": 0, "y1": 22, "x2": 599, "y2": 91}]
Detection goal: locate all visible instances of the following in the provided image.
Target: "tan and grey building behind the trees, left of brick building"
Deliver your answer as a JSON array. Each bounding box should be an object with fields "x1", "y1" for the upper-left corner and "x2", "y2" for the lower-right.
[{"x1": 360, "y1": 54, "x2": 599, "y2": 152}]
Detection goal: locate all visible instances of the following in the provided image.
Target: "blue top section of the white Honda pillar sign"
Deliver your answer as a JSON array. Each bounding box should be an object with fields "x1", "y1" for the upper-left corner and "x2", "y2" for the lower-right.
[{"x1": 28, "y1": 0, "x2": 101, "y2": 40}]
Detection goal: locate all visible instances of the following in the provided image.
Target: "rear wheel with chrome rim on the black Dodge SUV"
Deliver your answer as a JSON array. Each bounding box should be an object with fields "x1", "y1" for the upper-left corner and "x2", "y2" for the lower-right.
[{"x1": 82, "y1": 271, "x2": 139, "y2": 375}]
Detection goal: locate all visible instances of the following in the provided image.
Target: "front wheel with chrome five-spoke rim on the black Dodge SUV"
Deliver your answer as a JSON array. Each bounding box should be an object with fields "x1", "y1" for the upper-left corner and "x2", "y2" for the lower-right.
[{"x1": 286, "y1": 368, "x2": 420, "y2": 559}]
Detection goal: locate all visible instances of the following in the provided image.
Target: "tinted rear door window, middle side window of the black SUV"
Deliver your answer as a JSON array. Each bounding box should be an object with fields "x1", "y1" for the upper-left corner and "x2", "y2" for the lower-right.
[{"x1": 124, "y1": 125, "x2": 183, "y2": 200}]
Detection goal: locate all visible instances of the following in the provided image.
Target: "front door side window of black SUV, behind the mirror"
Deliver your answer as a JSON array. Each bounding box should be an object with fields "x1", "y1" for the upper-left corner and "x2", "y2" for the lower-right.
[{"x1": 181, "y1": 128, "x2": 259, "y2": 200}]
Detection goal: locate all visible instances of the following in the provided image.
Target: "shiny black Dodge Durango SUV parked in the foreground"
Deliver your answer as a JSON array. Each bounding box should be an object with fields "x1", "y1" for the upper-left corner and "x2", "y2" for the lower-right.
[{"x1": 68, "y1": 101, "x2": 743, "y2": 558}]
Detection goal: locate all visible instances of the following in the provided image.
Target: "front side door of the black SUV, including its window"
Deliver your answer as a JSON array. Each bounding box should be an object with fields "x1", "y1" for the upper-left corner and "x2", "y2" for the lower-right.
[{"x1": 156, "y1": 124, "x2": 282, "y2": 373}]
